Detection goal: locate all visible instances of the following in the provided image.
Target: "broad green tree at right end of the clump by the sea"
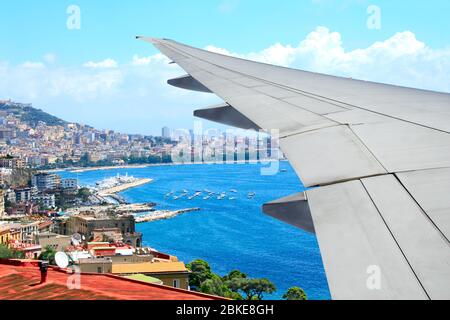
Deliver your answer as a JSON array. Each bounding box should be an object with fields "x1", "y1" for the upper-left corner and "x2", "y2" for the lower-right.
[{"x1": 227, "y1": 277, "x2": 276, "y2": 300}]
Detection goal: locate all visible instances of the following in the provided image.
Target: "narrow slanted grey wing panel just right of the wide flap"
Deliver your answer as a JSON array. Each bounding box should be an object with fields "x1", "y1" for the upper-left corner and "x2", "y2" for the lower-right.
[{"x1": 362, "y1": 175, "x2": 450, "y2": 299}]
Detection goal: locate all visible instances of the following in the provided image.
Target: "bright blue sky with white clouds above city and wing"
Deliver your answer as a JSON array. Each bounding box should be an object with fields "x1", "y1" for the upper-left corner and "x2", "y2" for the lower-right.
[{"x1": 0, "y1": 0, "x2": 450, "y2": 134}]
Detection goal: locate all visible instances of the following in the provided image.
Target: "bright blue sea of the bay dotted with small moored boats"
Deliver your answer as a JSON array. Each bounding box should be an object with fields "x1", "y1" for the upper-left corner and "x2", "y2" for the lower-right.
[{"x1": 60, "y1": 162, "x2": 330, "y2": 299}]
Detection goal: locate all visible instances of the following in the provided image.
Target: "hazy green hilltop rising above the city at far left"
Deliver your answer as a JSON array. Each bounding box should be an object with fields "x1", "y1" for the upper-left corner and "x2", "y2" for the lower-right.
[{"x1": 0, "y1": 101, "x2": 67, "y2": 127}]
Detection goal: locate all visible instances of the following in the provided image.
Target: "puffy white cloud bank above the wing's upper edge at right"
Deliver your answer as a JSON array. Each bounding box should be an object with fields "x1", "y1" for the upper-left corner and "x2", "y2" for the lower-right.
[{"x1": 206, "y1": 27, "x2": 450, "y2": 92}]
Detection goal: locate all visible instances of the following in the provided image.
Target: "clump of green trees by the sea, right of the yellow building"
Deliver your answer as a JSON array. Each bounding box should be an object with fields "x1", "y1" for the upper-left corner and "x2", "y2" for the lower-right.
[{"x1": 187, "y1": 260, "x2": 284, "y2": 300}]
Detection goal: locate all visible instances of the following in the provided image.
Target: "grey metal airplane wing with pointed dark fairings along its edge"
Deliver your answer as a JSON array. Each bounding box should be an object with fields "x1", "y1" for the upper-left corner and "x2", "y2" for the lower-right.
[{"x1": 139, "y1": 37, "x2": 450, "y2": 299}]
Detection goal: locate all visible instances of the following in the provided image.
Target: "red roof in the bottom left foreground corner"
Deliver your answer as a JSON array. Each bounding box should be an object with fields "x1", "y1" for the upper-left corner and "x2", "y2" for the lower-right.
[{"x1": 0, "y1": 260, "x2": 222, "y2": 300}]
